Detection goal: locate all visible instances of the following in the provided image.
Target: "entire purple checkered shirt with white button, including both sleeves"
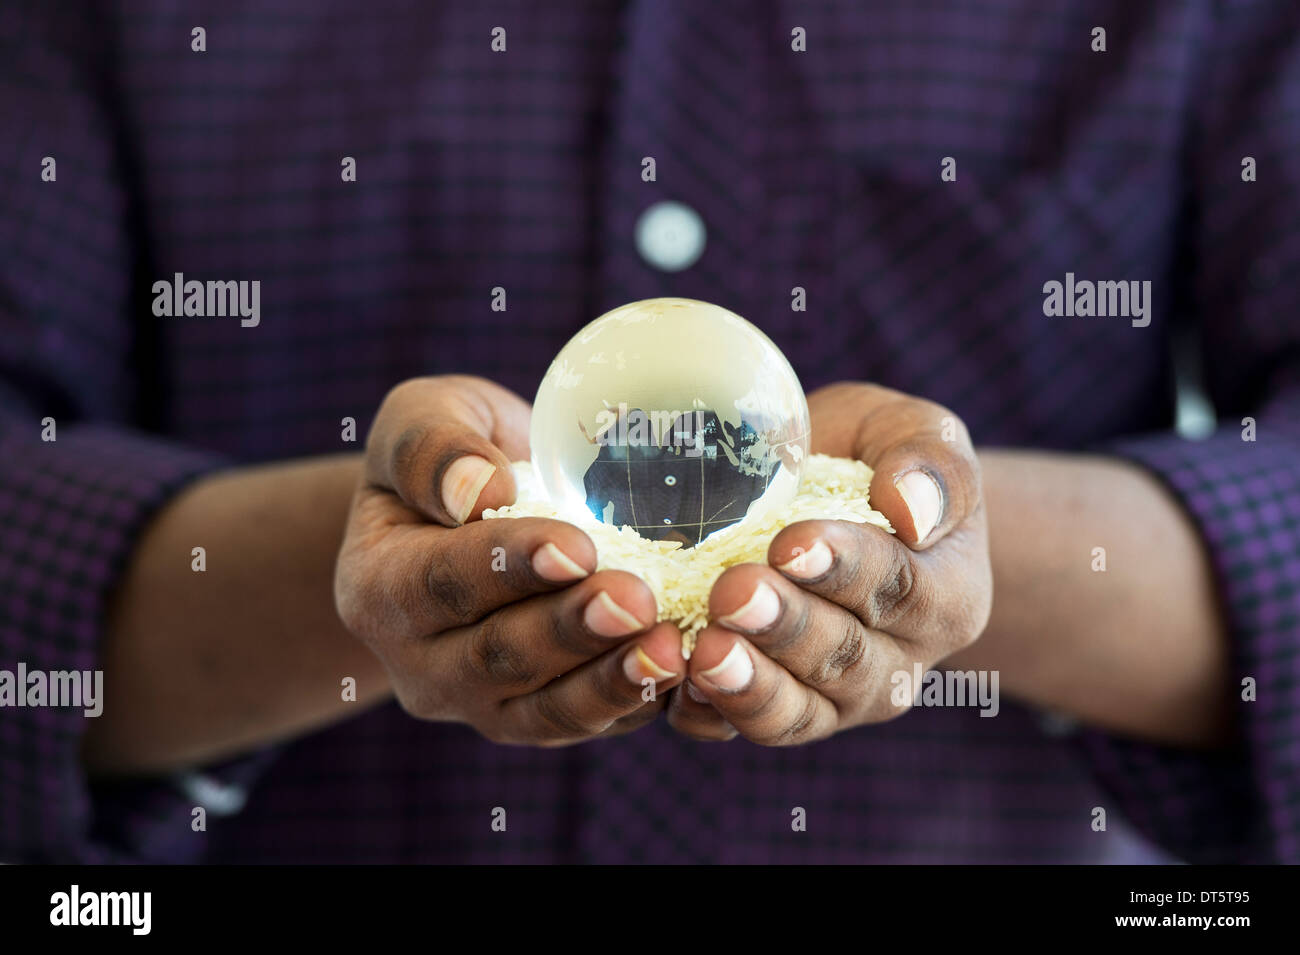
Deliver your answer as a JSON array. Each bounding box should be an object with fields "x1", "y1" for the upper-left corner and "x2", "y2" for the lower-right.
[{"x1": 0, "y1": 0, "x2": 1300, "y2": 863}]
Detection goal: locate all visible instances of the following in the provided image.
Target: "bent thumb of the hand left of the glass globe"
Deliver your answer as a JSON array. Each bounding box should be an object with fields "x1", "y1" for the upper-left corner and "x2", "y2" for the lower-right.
[{"x1": 365, "y1": 376, "x2": 530, "y2": 528}]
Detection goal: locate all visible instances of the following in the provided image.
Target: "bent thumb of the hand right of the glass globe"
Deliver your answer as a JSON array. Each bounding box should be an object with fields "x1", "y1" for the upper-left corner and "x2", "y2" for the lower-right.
[{"x1": 810, "y1": 385, "x2": 980, "y2": 550}]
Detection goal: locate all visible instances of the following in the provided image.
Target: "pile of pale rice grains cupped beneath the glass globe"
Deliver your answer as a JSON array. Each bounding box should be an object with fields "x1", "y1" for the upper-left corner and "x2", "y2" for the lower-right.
[{"x1": 484, "y1": 455, "x2": 893, "y2": 660}]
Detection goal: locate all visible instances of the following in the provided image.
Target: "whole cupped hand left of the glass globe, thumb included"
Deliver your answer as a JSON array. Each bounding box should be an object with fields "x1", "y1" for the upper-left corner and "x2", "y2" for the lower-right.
[{"x1": 334, "y1": 376, "x2": 685, "y2": 746}]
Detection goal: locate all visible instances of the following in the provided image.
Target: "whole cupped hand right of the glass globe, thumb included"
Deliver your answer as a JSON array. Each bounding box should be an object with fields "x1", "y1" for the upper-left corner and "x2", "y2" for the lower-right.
[{"x1": 668, "y1": 383, "x2": 993, "y2": 746}]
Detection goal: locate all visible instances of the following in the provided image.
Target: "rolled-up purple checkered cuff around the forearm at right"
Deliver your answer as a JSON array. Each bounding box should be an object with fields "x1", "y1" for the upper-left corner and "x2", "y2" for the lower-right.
[{"x1": 1076, "y1": 429, "x2": 1300, "y2": 863}]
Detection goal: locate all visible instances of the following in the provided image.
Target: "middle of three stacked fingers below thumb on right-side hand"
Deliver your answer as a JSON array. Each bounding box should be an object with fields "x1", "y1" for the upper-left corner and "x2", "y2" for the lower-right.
[{"x1": 709, "y1": 561, "x2": 910, "y2": 720}]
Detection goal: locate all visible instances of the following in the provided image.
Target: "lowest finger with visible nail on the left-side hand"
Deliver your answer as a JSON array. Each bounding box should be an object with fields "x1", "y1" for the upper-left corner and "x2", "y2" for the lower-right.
[{"x1": 498, "y1": 622, "x2": 685, "y2": 746}]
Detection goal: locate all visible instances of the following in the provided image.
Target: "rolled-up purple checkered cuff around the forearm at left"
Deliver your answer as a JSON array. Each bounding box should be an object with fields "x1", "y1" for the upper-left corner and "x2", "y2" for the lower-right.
[{"x1": 0, "y1": 425, "x2": 270, "y2": 863}]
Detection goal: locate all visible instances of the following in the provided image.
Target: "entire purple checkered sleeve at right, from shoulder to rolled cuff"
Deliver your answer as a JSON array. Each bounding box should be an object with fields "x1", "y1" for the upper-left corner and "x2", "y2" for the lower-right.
[{"x1": 1079, "y1": 0, "x2": 1300, "y2": 863}]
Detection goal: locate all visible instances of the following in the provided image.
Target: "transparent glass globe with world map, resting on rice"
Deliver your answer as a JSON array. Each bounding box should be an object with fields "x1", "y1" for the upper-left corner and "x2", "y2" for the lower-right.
[{"x1": 529, "y1": 299, "x2": 809, "y2": 547}]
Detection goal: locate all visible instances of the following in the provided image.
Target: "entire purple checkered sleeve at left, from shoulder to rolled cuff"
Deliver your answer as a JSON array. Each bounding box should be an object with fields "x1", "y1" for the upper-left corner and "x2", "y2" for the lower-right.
[{"x1": 0, "y1": 4, "x2": 274, "y2": 863}]
